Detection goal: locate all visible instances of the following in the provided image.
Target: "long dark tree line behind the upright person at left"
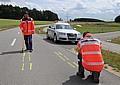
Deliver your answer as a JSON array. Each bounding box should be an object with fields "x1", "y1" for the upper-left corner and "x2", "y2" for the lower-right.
[{"x1": 0, "y1": 5, "x2": 58, "y2": 21}]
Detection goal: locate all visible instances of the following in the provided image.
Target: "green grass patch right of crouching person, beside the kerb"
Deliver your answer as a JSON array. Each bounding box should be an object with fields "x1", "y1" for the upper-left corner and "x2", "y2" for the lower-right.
[{"x1": 102, "y1": 50, "x2": 120, "y2": 70}]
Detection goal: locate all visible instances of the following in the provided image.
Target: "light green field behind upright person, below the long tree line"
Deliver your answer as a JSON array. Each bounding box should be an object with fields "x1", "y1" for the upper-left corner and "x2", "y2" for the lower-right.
[{"x1": 0, "y1": 19, "x2": 53, "y2": 30}]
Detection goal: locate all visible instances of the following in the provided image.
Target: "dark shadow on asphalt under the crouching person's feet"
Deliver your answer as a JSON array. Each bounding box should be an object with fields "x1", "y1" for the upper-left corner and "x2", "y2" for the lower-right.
[{"x1": 62, "y1": 75, "x2": 99, "y2": 85}]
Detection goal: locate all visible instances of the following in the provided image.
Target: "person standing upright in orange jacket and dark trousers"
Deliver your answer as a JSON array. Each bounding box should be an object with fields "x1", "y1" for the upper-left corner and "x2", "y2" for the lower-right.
[{"x1": 19, "y1": 12, "x2": 35, "y2": 52}]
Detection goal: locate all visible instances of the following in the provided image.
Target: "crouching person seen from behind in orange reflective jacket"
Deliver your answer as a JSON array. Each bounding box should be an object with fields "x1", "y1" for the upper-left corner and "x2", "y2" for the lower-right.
[{"x1": 76, "y1": 32, "x2": 104, "y2": 83}]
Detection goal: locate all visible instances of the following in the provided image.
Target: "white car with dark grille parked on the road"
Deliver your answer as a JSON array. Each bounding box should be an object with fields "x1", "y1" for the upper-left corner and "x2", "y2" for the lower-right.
[{"x1": 47, "y1": 22, "x2": 81, "y2": 43}]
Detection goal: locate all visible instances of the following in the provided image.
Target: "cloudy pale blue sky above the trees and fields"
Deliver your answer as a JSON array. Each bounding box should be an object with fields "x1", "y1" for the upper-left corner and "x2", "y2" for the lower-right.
[{"x1": 0, "y1": 0, "x2": 120, "y2": 21}]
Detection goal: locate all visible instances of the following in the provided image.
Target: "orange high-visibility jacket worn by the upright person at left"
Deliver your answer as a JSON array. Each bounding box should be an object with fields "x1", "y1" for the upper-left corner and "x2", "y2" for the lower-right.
[{"x1": 19, "y1": 18, "x2": 35, "y2": 35}]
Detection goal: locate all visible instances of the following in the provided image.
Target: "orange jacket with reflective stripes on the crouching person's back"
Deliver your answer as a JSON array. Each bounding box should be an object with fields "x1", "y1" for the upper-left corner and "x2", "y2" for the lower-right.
[{"x1": 79, "y1": 39, "x2": 104, "y2": 72}]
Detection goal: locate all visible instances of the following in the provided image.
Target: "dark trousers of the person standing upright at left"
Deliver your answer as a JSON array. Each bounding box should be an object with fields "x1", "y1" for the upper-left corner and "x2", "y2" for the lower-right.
[{"x1": 24, "y1": 35, "x2": 32, "y2": 50}]
